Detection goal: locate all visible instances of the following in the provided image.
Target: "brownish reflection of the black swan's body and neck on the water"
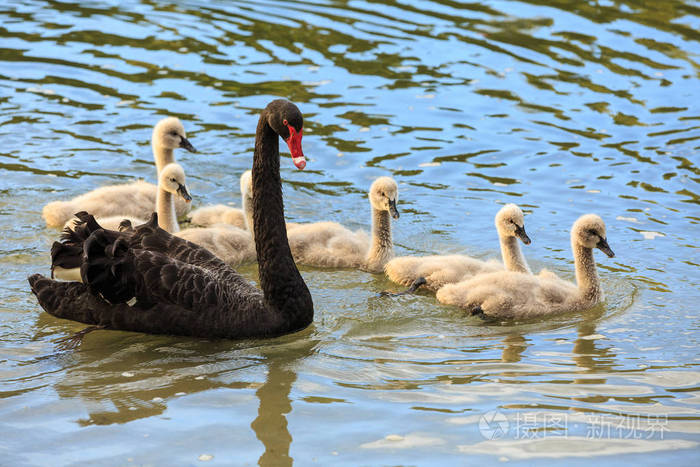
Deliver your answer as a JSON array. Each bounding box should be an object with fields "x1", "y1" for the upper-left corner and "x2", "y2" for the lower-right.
[{"x1": 54, "y1": 331, "x2": 319, "y2": 466}]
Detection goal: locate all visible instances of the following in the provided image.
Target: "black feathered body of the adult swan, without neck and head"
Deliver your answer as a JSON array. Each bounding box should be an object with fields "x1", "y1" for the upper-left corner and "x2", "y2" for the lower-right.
[{"x1": 29, "y1": 227, "x2": 286, "y2": 338}]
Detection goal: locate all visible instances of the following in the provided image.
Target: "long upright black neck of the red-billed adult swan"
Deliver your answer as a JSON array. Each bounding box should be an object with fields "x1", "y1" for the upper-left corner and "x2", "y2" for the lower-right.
[{"x1": 253, "y1": 112, "x2": 313, "y2": 329}]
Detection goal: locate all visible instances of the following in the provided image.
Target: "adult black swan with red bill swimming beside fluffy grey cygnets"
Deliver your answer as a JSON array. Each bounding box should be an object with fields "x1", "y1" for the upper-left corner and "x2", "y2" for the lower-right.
[{"x1": 29, "y1": 99, "x2": 313, "y2": 339}]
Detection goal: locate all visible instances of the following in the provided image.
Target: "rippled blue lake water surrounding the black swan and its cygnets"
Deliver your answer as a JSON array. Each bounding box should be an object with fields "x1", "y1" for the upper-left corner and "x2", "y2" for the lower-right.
[{"x1": 0, "y1": 0, "x2": 700, "y2": 466}]
